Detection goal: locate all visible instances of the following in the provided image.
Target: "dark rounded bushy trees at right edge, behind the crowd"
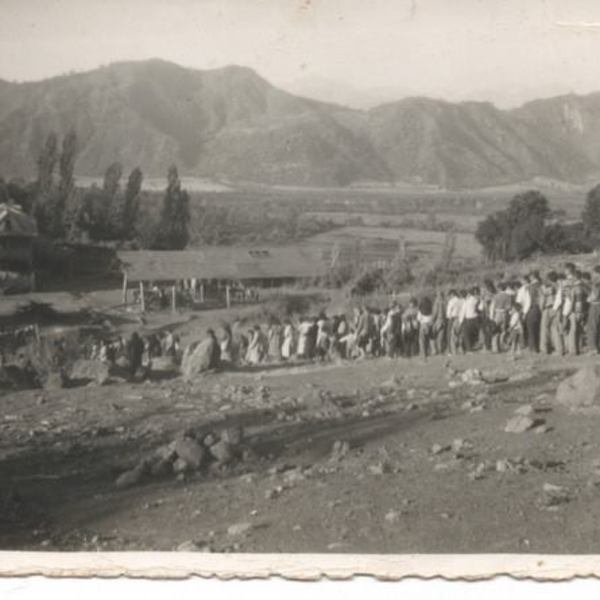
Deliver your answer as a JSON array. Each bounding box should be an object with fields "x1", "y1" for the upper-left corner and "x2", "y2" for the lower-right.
[{"x1": 475, "y1": 184, "x2": 600, "y2": 262}]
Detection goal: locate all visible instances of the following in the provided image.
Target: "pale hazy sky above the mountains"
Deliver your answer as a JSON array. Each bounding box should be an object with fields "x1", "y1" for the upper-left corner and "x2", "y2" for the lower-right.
[{"x1": 0, "y1": 0, "x2": 600, "y2": 106}]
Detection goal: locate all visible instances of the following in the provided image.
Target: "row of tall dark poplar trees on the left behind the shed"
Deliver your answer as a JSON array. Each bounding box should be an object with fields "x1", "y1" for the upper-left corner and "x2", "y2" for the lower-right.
[{"x1": 0, "y1": 130, "x2": 190, "y2": 250}]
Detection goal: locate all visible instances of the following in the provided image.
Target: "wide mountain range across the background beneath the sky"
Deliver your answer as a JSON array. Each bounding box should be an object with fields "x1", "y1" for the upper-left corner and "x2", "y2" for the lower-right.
[{"x1": 0, "y1": 60, "x2": 600, "y2": 189}]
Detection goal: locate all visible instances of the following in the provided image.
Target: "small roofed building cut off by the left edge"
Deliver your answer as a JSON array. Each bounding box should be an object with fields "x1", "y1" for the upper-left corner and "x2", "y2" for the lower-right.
[{"x1": 0, "y1": 202, "x2": 37, "y2": 293}]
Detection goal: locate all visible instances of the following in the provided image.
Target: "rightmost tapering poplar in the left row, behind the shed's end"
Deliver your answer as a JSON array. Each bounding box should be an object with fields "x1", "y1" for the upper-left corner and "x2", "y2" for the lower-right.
[{"x1": 152, "y1": 165, "x2": 190, "y2": 250}]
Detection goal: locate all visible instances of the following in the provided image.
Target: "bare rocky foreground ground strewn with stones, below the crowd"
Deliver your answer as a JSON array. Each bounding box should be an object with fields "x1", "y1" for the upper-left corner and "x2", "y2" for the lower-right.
[{"x1": 0, "y1": 354, "x2": 600, "y2": 553}]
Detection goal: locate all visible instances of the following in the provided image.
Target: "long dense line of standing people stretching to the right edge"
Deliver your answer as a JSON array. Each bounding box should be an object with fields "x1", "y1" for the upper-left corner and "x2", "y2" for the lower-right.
[{"x1": 219, "y1": 263, "x2": 600, "y2": 365}]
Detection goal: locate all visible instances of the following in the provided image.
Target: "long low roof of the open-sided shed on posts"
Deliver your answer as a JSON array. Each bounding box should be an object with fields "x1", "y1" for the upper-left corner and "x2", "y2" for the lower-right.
[{"x1": 117, "y1": 246, "x2": 328, "y2": 281}]
